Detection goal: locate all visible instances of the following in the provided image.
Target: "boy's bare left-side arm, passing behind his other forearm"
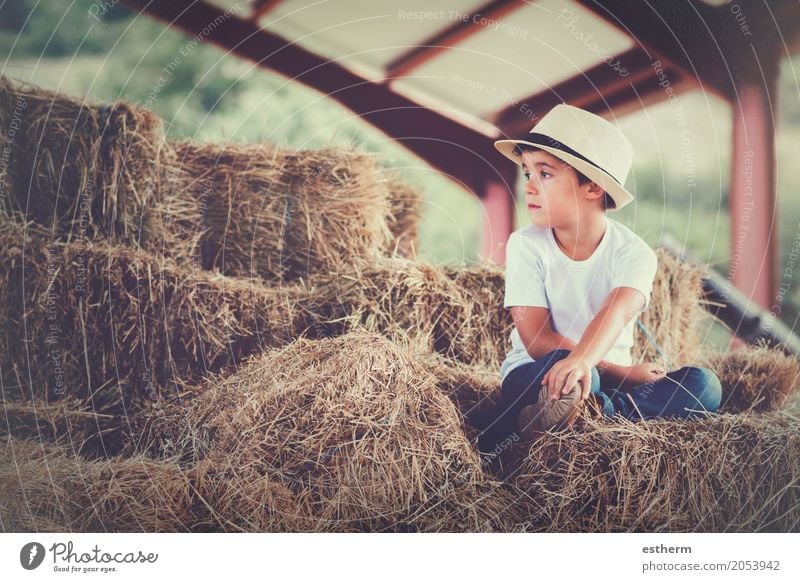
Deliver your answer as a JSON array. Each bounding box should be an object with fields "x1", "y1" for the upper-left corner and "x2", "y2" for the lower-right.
[{"x1": 511, "y1": 307, "x2": 628, "y2": 382}]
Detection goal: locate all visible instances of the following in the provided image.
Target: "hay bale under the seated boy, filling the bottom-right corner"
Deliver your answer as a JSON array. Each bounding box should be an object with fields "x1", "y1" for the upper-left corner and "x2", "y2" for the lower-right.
[{"x1": 511, "y1": 413, "x2": 800, "y2": 532}]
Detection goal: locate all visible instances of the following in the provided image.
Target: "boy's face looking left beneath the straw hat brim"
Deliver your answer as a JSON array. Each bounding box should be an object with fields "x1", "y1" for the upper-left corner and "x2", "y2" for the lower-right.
[{"x1": 522, "y1": 150, "x2": 592, "y2": 227}]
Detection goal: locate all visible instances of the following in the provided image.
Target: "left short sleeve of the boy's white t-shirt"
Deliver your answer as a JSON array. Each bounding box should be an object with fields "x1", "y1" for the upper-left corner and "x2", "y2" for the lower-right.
[{"x1": 503, "y1": 233, "x2": 550, "y2": 307}]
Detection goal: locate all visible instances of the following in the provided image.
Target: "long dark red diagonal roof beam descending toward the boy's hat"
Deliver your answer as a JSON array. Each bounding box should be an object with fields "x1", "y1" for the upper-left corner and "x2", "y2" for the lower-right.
[{"x1": 123, "y1": 0, "x2": 499, "y2": 196}]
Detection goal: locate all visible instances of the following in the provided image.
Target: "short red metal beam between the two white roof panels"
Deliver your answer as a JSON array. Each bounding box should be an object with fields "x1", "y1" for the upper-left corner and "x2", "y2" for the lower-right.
[{"x1": 386, "y1": 0, "x2": 526, "y2": 81}]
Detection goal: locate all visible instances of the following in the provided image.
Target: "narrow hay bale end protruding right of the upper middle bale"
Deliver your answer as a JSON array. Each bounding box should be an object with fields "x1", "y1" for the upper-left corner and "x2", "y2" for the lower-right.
[{"x1": 386, "y1": 176, "x2": 424, "y2": 258}]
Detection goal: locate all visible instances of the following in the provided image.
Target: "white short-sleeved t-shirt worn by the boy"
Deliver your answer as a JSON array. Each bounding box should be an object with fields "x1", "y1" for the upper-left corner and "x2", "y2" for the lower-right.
[{"x1": 500, "y1": 216, "x2": 658, "y2": 379}]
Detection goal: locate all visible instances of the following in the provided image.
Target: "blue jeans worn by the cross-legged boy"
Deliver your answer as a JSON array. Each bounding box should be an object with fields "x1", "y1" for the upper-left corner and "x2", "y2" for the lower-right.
[{"x1": 478, "y1": 349, "x2": 722, "y2": 452}]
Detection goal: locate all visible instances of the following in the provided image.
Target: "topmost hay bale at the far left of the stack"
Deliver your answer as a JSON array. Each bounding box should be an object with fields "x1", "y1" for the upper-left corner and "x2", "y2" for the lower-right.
[{"x1": 0, "y1": 77, "x2": 179, "y2": 252}]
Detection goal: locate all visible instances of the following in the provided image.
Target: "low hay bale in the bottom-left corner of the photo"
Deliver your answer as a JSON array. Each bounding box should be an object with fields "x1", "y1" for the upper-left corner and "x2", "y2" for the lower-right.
[{"x1": 0, "y1": 438, "x2": 203, "y2": 533}]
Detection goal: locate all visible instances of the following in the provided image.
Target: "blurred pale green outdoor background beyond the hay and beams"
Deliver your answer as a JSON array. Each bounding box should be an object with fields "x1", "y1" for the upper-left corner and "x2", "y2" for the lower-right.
[{"x1": 0, "y1": 0, "x2": 800, "y2": 328}]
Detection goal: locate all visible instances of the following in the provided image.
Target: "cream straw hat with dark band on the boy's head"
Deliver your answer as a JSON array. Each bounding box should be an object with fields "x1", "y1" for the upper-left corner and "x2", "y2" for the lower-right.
[{"x1": 494, "y1": 103, "x2": 633, "y2": 210}]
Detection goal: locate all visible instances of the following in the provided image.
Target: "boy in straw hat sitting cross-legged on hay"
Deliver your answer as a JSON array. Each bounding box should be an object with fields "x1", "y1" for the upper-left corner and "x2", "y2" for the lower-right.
[{"x1": 479, "y1": 104, "x2": 721, "y2": 452}]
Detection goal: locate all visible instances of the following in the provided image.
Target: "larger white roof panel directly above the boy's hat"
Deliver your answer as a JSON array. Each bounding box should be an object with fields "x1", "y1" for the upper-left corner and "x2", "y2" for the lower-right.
[{"x1": 392, "y1": 0, "x2": 633, "y2": 117}]
